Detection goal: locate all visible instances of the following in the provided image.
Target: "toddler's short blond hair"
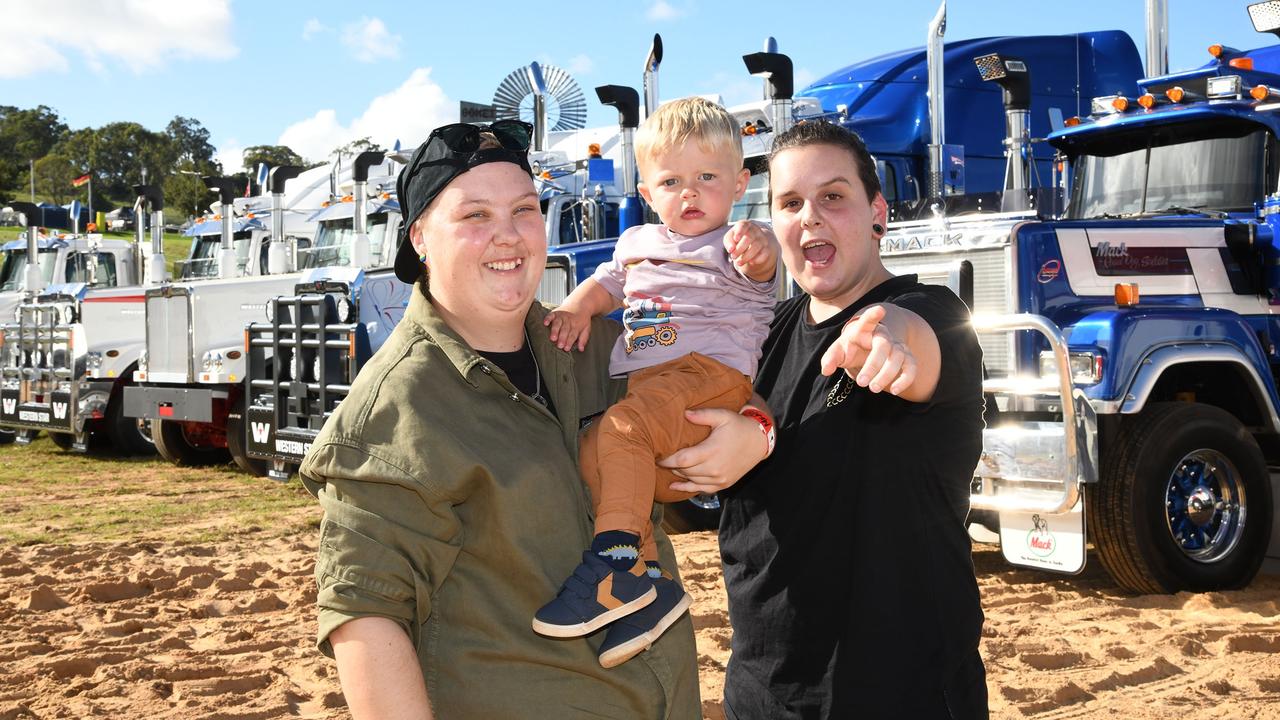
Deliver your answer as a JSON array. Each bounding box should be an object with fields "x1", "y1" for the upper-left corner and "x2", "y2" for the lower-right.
[{"x1": 635, "y1": 97, "x2": 742, "y2": 167}]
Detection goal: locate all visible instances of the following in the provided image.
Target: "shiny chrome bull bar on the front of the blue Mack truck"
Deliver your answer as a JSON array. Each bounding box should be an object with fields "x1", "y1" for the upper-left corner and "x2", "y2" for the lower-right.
[{"x1": 969, "y1": 314, "x2": 1098, "y2": 514}]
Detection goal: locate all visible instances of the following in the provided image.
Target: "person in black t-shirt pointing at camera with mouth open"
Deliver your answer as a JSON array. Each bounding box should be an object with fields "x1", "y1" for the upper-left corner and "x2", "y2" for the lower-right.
[{"x1": 721, "y1": 123, "x2": 987, "y2": 720}]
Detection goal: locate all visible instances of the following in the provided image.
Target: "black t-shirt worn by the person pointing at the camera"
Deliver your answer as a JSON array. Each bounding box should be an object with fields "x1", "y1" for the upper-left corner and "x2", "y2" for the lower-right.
[{"x1": 719, "y1": 275, "x2": 983, "y2": 720}]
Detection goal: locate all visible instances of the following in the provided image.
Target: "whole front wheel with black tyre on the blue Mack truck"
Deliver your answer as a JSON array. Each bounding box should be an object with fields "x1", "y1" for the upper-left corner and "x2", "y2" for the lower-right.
[{"x1": 1085, "y1": 402, "x2": 1271, "y2": 593}]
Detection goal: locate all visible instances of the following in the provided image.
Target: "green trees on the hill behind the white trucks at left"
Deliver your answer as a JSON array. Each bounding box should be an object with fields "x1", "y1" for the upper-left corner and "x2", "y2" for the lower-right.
[{"x1": 0, "y1": 105, "x2": 378, "y2": 219}]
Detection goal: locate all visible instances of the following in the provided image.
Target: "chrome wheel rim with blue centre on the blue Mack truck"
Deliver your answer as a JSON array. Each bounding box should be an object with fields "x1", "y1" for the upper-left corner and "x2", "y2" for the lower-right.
[{"x1": 1165, "y1": 448, "x2": 1245, "y2": 564}]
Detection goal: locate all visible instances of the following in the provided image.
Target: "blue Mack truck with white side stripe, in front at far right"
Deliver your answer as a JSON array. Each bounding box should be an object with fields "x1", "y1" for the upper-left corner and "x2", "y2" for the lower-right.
[{"x1": 881, "y1": 1, "x2": 1280, "y2": 592}]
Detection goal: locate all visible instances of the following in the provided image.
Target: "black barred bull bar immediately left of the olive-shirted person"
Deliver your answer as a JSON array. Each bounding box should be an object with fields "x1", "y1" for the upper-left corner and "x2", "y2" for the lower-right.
[{"x1": 246, "y1": 283, "x2": 371, "y2": 462}]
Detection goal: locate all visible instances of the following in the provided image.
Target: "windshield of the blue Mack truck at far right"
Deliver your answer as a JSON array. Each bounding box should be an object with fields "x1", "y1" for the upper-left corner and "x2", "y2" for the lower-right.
[{"x1": 1068, "y1": 126, "x2": 1267, "y2": 218}]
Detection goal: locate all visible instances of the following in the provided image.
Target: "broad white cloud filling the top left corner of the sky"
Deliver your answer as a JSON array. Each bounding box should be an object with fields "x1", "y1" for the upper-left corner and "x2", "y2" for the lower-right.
[{"x1": 0, "y1": 0, "x2": 239, "y2": 78}]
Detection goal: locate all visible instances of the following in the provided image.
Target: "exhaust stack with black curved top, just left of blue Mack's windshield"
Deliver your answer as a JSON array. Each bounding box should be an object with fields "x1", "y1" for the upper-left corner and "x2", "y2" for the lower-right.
[{"x1": 973, "y1": 53, "x2": 1032, "y2": 211}]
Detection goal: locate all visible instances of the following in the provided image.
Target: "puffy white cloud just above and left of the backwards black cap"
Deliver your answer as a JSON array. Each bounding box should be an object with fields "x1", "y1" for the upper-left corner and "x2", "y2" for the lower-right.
[{"x1": 278, "y1": 68, "x2": 458, "y2": 160}]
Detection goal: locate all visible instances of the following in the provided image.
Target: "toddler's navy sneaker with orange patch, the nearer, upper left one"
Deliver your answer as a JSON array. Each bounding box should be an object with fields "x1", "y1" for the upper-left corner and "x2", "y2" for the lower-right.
[{"x1": 534, "y1": 551, "x2": 658, "y2": 638}]
